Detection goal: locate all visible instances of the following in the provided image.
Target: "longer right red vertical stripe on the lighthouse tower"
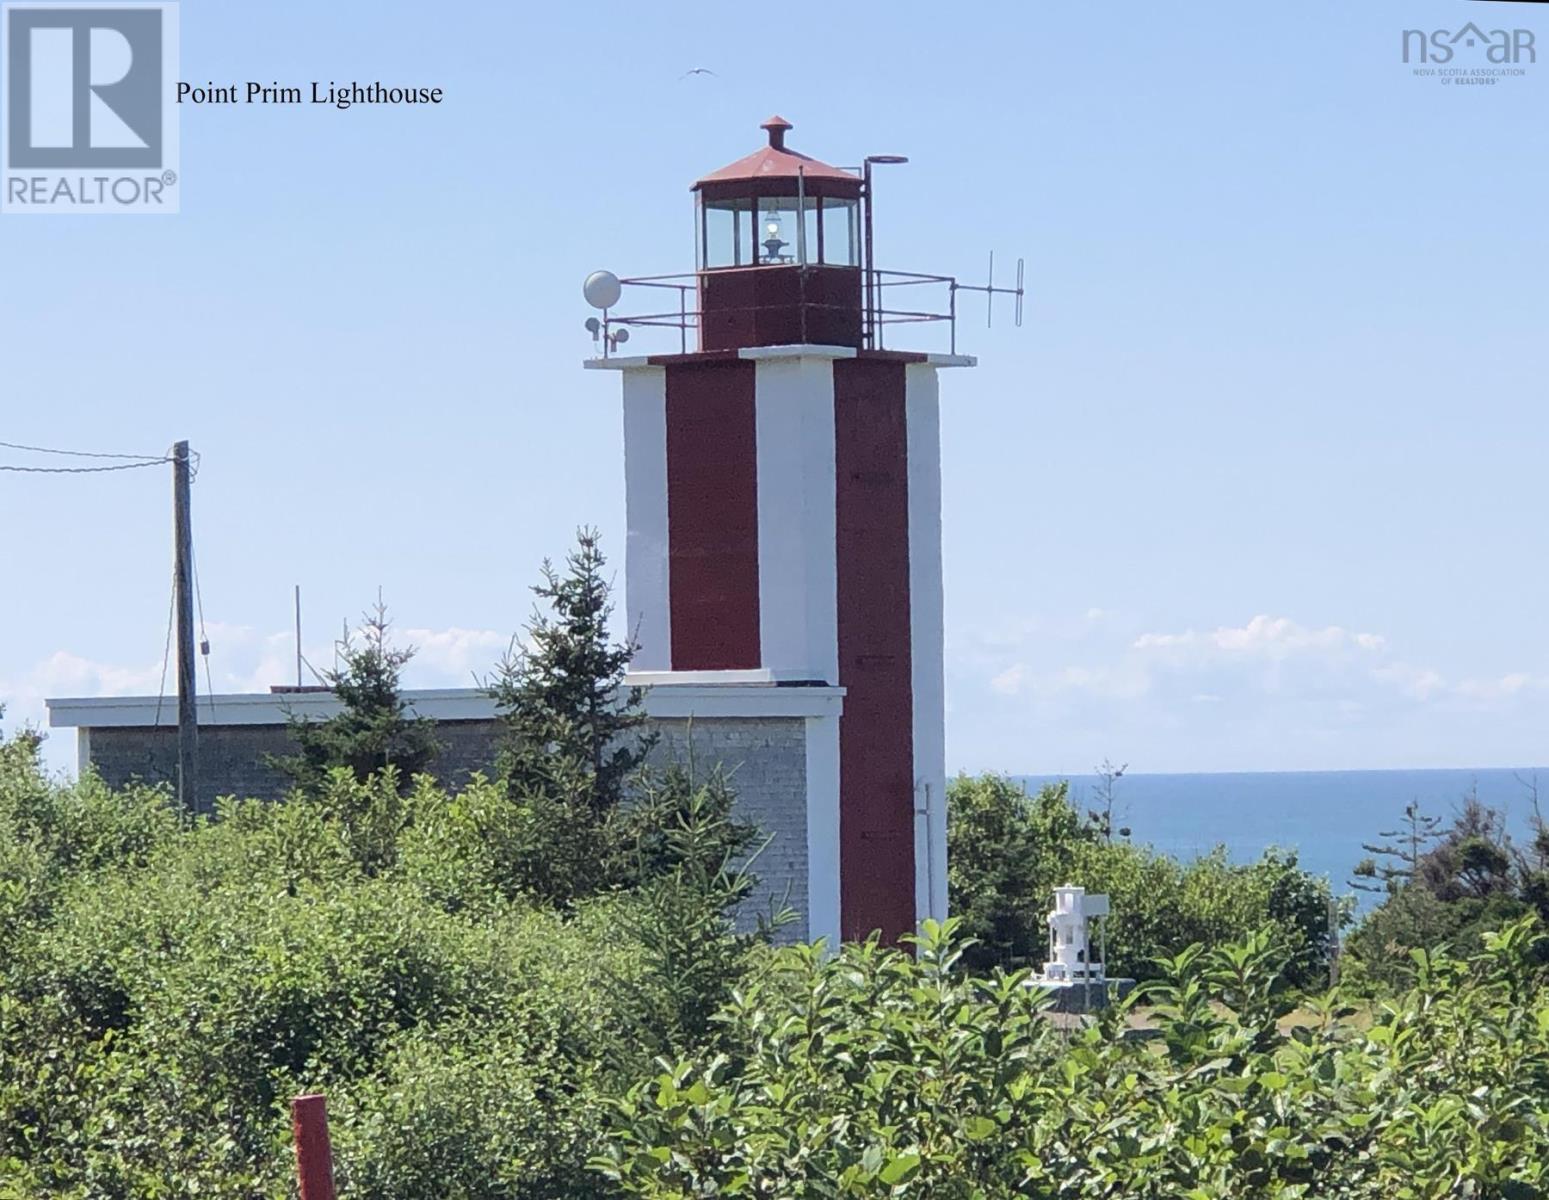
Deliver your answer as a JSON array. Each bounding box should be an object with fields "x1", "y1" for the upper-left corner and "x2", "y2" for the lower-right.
[{"x1": 833, "y1": 359, "x2": 915, "y2": 941}]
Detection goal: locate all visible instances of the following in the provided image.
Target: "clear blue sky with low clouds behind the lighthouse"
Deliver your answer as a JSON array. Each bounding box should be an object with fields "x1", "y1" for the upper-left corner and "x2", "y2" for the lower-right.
[{"x1": 0, "y1": 0, "x2": 1549, "y2": 773}]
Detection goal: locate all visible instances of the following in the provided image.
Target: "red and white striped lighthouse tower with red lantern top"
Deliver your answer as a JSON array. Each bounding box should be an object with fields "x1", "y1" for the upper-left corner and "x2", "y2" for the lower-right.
[{"x1": 589, "y1": 118, "x2": 1003, "y2": 940}]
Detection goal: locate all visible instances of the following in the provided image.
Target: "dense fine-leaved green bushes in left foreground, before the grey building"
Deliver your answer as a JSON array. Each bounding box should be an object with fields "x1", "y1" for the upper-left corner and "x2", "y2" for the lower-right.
[{"x1": 0, "y1": 727, "x2": 759, "y2": 1200}]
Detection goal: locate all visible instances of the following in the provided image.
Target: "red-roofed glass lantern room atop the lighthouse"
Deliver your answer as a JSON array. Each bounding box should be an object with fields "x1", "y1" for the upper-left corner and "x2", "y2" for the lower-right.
[{"x1": 692, "y1": 116, "x2": 864, "y2": 350}]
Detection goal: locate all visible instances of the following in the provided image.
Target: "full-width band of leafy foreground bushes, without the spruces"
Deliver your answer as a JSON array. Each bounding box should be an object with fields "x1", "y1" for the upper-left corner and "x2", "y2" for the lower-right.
[{"x1": 0, "y1": 740, "x2": 1549, "y2": 1200}]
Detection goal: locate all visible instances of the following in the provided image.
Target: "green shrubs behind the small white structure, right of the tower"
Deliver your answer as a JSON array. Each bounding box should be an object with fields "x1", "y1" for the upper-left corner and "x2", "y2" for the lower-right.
[{"x1": 946, "y1": 768, "x2": 1331, "y2": 988}]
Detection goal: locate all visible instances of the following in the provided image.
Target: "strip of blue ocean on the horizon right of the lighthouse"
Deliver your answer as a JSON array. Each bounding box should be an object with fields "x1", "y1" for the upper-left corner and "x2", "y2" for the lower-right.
[{"x1": 1018, "y1": 766, "x2": 1549, "y2": 895}]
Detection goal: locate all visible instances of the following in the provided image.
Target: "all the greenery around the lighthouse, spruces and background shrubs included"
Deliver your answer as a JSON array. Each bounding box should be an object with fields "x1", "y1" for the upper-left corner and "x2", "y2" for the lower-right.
[{"x1": 0, "y1": 533, "x2": 1549, "y2": 1200}]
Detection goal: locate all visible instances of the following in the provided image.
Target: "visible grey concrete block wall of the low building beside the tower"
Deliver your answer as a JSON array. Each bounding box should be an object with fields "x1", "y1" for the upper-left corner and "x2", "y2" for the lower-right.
[{"x1": 81, "y1": 717, "x2": 807, "y2": 941}]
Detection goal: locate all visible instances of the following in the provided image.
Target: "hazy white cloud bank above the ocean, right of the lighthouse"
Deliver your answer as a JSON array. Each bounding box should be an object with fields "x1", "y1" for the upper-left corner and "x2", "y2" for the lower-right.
[{"x1": 946, "y1": 605, "x2": 1549, "y2": 771}]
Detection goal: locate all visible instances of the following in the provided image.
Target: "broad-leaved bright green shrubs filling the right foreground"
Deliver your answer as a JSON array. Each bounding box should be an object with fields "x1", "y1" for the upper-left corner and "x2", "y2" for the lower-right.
[{"x1": 596, "y1": 923, "x2": 1549, "y2": 1200}]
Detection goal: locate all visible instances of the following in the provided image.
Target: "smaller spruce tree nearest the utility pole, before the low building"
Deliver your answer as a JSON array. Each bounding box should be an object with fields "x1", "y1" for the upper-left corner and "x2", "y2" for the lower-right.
[{"x1": 270, "y1": 598, "x2": 440, "y2": 793}]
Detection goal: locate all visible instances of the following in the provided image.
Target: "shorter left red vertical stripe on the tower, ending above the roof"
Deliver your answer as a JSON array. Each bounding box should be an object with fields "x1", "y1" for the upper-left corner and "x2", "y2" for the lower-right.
[{"x1": 666, "y1": 362, "x2": 761, "y2": 670}]
